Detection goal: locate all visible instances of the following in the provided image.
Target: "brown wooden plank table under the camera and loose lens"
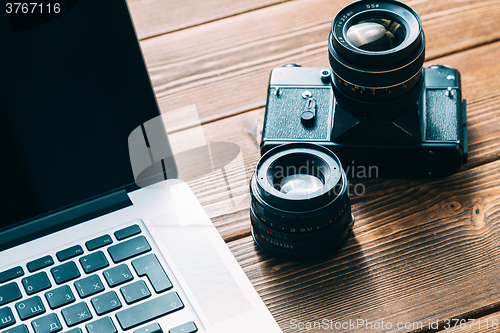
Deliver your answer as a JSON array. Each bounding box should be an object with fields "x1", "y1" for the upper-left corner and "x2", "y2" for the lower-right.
[{"x1": 129, "y1": 0, "x2": 500, "y2": 332}]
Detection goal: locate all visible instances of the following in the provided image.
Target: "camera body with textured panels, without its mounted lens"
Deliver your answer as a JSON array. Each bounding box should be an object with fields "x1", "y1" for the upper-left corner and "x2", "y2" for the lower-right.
[{"x1": 261, "y1": 65, "x2": 467, "y2": 178}]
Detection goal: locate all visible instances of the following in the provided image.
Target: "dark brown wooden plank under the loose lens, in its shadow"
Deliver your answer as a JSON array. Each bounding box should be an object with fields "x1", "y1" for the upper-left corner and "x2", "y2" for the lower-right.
[{"x1": 228, "y1": 161, "x2": 500, "y2": 332}]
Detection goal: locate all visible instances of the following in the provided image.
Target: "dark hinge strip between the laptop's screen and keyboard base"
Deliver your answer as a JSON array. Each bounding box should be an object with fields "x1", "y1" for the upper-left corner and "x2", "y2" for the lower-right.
[{"x1": 0, "y1": 190, "x2": 132, "y2": 251}]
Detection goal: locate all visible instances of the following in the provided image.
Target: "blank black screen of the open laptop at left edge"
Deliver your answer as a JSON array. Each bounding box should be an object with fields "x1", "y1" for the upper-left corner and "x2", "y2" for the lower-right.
[{"x1": 0, "y1": 0, "x2": 172, "y2": 231}]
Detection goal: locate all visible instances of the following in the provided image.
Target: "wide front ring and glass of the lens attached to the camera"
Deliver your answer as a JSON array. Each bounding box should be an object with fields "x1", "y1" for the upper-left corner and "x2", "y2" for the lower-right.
[{"x1": 330, "y1": 0, "x2": 422, "y2": 68}]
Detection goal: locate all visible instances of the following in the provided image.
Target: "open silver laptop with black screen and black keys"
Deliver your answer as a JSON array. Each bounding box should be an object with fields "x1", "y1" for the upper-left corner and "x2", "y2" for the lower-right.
[{"x1": 0, "y1": 0, "x2": 281, "y2": 333}]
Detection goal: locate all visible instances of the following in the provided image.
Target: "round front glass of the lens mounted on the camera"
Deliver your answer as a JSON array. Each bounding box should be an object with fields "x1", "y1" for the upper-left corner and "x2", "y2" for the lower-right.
[{"x1": 347, "y1": 18, "x2": 406, "y2": 51}]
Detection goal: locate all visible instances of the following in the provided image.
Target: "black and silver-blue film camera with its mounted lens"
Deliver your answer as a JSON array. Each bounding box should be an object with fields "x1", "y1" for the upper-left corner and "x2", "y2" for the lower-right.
[{"x1": 261, "y1": 0, "x2": 467, "y2": 177}]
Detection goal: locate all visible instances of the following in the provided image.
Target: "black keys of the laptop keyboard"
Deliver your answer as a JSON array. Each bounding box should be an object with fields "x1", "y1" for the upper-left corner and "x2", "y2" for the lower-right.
[{"x1": 0, "y1": 224, "x2": 198, "y2": 333}]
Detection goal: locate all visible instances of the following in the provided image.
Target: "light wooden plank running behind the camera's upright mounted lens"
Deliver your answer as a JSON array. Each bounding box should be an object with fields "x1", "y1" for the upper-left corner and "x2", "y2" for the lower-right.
[{"x1": 141, "y1": 0, "x2": 500, "y2": 128}]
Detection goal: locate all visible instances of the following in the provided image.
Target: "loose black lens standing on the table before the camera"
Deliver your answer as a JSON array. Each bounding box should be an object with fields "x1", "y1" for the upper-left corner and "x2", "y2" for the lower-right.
[{"x1": 250, "y1": 143, "x2": 353, "y2": 261}]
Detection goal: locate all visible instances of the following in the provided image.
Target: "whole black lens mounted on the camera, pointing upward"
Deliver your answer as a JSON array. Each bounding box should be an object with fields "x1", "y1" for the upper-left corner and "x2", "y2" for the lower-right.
[{"x1": 328, "y1": 0, "x2": 425, "y2": 120}]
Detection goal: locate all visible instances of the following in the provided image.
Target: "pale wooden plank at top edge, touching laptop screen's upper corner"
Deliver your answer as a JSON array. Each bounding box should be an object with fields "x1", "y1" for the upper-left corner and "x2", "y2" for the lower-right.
[{"x1": 127, "y1": 0, "x2": 286, "y2": 39}]
